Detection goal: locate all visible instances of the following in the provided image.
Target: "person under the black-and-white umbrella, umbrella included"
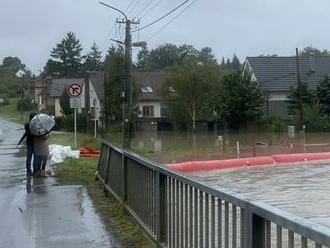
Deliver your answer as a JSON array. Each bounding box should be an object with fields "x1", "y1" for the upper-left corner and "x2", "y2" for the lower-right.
[{"x1": 30, "y1": 114, "x2": 55, "y2": 177}]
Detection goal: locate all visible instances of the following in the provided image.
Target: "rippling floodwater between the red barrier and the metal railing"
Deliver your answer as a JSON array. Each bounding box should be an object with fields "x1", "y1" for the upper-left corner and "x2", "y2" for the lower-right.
[{"x1": 190, "y1": 161, "x2": 330, "y2": 227}]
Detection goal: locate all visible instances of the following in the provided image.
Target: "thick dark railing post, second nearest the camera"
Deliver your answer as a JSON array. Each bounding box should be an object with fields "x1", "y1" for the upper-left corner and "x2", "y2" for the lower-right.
[{"x1": 156, "y1": 171, "x2": 167, "y2": 247}]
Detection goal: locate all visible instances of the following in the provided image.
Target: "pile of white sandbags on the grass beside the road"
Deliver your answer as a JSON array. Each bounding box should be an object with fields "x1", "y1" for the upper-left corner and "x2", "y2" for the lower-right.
[{"x1": 49, "y1": 145, "x2": 80, "y2": 165}]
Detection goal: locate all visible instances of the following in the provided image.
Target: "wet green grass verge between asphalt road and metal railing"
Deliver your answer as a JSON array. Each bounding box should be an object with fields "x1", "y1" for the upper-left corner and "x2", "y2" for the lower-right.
[{"x1": 51, "y1": 136, "x2": 155, "y2": 247}]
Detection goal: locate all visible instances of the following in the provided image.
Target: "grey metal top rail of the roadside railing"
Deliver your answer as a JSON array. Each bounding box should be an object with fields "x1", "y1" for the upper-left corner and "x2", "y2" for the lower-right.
[{"x1": 100, "y1": 141, "x2": 330, "y2": 246}]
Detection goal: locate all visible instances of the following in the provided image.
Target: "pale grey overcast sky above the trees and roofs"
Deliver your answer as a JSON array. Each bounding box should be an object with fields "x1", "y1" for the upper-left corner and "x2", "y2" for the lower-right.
[{"x1": 0, "y1": 0, "x2": 330, "y2": 73}]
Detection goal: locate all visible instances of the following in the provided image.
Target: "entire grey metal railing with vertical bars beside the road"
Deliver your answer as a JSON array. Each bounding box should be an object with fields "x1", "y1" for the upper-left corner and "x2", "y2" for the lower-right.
[{"x1": 97, "y1": 141, "x2": 330, "y2": 248}]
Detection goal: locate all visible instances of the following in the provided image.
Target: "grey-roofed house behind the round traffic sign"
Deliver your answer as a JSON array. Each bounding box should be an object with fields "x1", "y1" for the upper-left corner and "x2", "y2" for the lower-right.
[{"x1": 34, "y1": 72, "x2": 105, "y2": 119}]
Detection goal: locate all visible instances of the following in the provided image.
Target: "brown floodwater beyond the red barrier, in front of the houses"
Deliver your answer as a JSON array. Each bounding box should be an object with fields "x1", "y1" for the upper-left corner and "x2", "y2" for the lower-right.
[{"x1": 104, "y1": 131, "x2": 330, "y2": 163}]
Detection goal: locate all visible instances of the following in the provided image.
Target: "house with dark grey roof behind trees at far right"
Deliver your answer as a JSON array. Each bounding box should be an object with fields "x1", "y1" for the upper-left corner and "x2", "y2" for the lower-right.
[{"x1": 243, "y1": 56, "x2": 330, "y2": 118}]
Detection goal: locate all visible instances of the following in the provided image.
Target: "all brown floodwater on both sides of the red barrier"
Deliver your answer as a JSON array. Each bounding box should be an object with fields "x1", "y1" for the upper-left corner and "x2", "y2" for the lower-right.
[{"x1": 110, "y1": 132, "x2": 330, "y2": 227}]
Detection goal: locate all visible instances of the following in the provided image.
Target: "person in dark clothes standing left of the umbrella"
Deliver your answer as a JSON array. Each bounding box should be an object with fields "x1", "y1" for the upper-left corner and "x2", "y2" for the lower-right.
[{"x1": 17, "y1": 113, "x2": 36, "y2": 176}]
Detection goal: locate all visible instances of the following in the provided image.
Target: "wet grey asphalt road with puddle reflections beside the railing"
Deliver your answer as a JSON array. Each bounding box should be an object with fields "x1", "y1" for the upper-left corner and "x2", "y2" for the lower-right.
[{"x1": 0, "y1": 119, "x2": 119, "y2": 248}]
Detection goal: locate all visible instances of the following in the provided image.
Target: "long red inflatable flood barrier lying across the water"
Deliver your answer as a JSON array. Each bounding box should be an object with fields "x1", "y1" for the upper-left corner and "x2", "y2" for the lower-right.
[{"x1": 166, "y1": 152, "x2": 330, "y2": 172}]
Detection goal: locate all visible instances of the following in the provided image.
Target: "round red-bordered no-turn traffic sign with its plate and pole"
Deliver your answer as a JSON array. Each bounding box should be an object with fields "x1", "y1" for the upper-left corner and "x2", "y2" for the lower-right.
[{"x1": 66, "y1": 83, "x2": 82, "y2": 149}]
